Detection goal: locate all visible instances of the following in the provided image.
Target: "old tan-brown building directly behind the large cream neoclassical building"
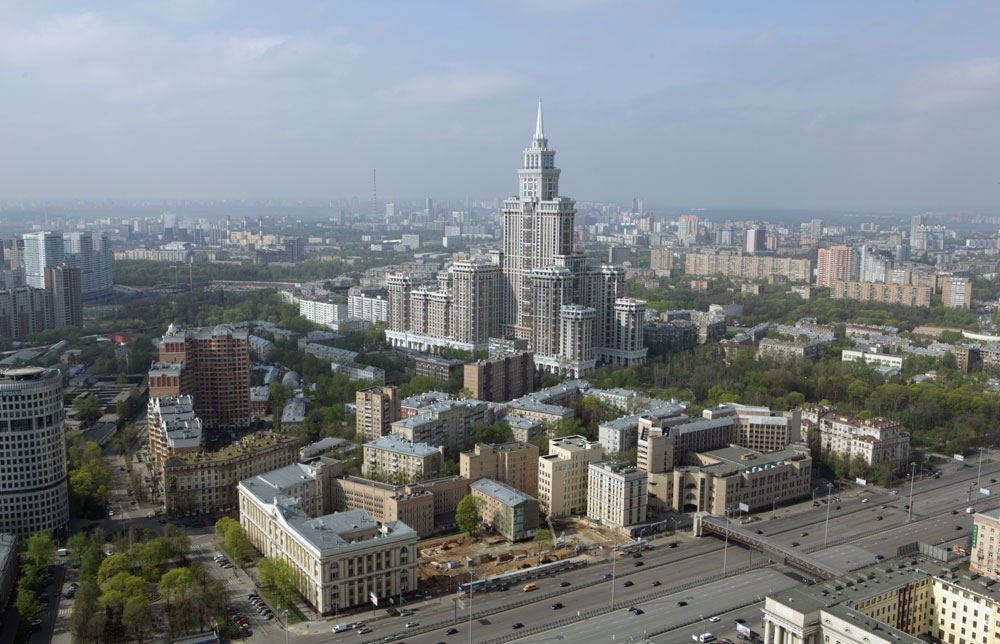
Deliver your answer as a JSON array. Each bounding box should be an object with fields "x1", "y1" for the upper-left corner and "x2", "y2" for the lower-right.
[{"x1": 161, "y1": 432, "x2": 299, "y2": 516}]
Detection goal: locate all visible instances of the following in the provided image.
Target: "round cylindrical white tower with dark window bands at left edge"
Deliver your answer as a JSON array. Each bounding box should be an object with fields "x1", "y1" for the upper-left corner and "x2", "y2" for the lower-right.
[{"x1": 0, "y1": 367, "x2": 69, "y2": 538}]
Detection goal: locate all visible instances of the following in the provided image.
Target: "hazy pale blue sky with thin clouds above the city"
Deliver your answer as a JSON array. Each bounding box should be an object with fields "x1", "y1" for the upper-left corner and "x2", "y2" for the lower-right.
[{"x1": 0, "y1": 0, "x2": 1000, "y2": 213}]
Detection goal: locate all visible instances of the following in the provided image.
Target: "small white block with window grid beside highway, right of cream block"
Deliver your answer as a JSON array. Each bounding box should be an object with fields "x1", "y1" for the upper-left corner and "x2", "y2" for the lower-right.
[{"x1": 587, "y1": 461, "x2": 648, "y2": 529}]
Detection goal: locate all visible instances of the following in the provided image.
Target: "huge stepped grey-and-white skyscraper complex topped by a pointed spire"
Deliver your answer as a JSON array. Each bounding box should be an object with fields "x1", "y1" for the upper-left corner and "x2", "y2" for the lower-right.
[{"x1": 386, "y1": 104, "x2": 646, "y2": 376}]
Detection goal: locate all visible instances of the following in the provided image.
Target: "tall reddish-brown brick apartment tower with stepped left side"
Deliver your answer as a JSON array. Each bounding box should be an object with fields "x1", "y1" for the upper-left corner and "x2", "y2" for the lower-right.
[{"x1": 149, "y1": 324, "x2": 252, "y2": 429}]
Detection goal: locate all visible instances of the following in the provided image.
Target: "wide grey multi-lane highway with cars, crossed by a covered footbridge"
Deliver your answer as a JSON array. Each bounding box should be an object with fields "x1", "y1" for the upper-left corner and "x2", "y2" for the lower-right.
[{"x1": 296, "y1": 463, "x2": 1000, "y2": 644}]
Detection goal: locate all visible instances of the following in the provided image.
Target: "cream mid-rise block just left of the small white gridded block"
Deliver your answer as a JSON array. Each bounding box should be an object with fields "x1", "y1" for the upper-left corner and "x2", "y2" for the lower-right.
[{"x1": 538, "y1": 435, "x2": 604, "y2": 518}]
